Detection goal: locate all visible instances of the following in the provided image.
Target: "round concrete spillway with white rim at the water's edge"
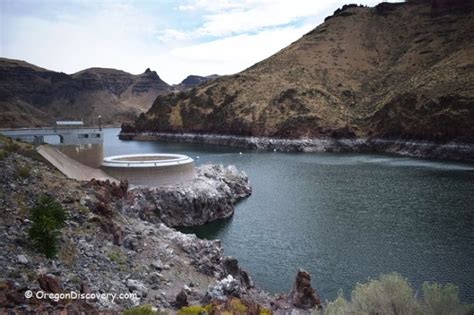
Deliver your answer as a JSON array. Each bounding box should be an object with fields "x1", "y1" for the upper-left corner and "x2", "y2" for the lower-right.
[{"x1": 101, "y1": 153, "x2": 194, "y2": 186}]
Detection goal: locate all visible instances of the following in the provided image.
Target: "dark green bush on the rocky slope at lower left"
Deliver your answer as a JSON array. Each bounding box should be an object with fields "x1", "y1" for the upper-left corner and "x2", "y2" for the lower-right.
[{"x1": 28, "y1": 196, "x2": 66, "y2": 258}]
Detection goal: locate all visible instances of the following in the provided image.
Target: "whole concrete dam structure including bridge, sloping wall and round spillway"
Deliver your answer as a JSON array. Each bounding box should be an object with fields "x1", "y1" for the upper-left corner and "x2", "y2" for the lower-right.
[{"x1": 0, "y1": 122, "x2": 195, "y2": 187}]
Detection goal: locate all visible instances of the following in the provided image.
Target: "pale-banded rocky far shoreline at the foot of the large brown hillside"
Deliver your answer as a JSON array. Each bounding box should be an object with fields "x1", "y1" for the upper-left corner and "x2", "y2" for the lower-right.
[{"x1": 119, "y1": 132, "x2": 474, "y2": 162}]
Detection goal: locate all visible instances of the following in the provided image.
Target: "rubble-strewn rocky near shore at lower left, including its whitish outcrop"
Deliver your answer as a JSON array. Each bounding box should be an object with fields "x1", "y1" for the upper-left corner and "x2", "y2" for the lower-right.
[{"x1": 0, "y1": 143, "x2": 320, "y2": 314}]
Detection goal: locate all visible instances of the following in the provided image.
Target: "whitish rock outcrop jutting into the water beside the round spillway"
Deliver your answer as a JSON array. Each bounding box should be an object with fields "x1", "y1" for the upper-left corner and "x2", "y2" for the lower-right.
[{"x1": 124, "y1": 164, "x2": 252, "y2": 226}]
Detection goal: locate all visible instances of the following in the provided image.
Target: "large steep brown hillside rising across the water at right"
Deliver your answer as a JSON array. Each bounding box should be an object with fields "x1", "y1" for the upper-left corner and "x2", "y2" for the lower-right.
[{"x1": 123, "y1": 1, "x2": 474, "y2": 141}]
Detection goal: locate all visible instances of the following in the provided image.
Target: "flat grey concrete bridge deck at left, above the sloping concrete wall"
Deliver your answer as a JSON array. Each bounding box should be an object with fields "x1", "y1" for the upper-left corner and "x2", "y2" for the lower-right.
[{"x1": 0, "y1": 127, "x2": 104, "y2": 145}]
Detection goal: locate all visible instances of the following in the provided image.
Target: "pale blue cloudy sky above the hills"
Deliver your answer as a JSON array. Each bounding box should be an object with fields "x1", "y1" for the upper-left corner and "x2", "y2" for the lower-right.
[{"x1": 0, "y1": 0, "x2": 392, "y2": 84}]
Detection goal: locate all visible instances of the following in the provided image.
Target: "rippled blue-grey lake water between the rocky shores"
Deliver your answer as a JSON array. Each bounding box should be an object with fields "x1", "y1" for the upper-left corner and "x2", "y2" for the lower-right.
[{"x1": 99, "y1": 129, "x2": 474, "y2": 303}]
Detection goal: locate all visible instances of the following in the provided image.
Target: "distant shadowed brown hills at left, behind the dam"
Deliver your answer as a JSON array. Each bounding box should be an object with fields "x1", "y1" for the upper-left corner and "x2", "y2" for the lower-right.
[{"x1": 0, "y1": 58, "x2": 171, "y2": 127}]
